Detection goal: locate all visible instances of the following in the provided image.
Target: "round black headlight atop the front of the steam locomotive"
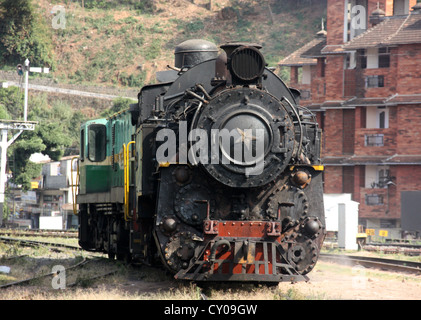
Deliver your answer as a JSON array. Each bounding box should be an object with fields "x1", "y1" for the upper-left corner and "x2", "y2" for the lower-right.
[{"x1": 228, "y1": 46, "x2": 266, "y2": 82}]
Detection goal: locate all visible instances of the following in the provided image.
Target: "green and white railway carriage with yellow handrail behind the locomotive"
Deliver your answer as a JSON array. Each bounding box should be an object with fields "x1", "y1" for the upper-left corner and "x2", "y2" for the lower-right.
[{"x1": 77, "y1": 110, "x2": 135, "y2": 255}]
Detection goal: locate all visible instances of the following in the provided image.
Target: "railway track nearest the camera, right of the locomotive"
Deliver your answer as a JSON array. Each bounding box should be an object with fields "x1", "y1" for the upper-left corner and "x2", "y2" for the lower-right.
[{"x1": 319, "y1": 253, "x2": 421, "y2": 275}]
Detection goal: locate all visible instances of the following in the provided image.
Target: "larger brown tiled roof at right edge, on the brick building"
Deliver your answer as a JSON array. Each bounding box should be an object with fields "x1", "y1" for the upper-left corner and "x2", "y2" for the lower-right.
[{"x1": 343, "y1": 13, "x2": 421, "y2": 50}]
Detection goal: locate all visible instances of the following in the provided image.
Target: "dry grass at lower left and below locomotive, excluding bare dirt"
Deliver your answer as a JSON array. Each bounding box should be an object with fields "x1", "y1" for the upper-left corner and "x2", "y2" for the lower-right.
[{"x1": 0, "y1": 238, "x2": 316, "y2": 301}]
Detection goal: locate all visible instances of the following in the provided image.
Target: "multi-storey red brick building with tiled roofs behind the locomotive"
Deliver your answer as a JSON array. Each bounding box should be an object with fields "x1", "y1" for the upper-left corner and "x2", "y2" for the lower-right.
[{"x1": 280, "y1": 0, "x2": 421, "y2": 237}]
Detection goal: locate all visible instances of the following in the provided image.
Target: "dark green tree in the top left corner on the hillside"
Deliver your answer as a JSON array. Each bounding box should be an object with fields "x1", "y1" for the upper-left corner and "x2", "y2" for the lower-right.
[{"x1": 0, "y1": 0, "x2": 54, "y2": 68}]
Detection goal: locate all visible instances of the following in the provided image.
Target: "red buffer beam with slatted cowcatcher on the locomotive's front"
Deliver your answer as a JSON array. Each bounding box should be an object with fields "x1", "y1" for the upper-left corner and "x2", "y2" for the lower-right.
[{"x1": 175, "y1": 220, "x2": 309, "y2": 282}]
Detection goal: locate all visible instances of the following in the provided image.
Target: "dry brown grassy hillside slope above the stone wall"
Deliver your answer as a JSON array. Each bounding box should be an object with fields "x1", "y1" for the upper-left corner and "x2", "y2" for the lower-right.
[{"x1": 5, "y1": 0, "x2": 326, "y2": 87}]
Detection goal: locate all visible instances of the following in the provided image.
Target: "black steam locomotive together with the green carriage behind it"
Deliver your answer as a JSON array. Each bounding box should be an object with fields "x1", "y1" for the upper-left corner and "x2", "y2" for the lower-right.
[{"x1": 77, "y1": 39, "x2": 326, "y2": 282}]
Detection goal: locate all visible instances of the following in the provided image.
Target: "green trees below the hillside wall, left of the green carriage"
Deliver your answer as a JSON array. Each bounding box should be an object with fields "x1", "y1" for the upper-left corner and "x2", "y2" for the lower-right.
[{"x1": 0, "y1": 87, "x2": 77, "y2": 190}]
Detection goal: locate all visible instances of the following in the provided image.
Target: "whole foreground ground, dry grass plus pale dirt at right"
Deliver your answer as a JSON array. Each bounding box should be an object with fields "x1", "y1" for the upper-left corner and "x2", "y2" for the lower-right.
[{"x1": 4, "y1": 239, "x2": 421, "y2": 303}]
